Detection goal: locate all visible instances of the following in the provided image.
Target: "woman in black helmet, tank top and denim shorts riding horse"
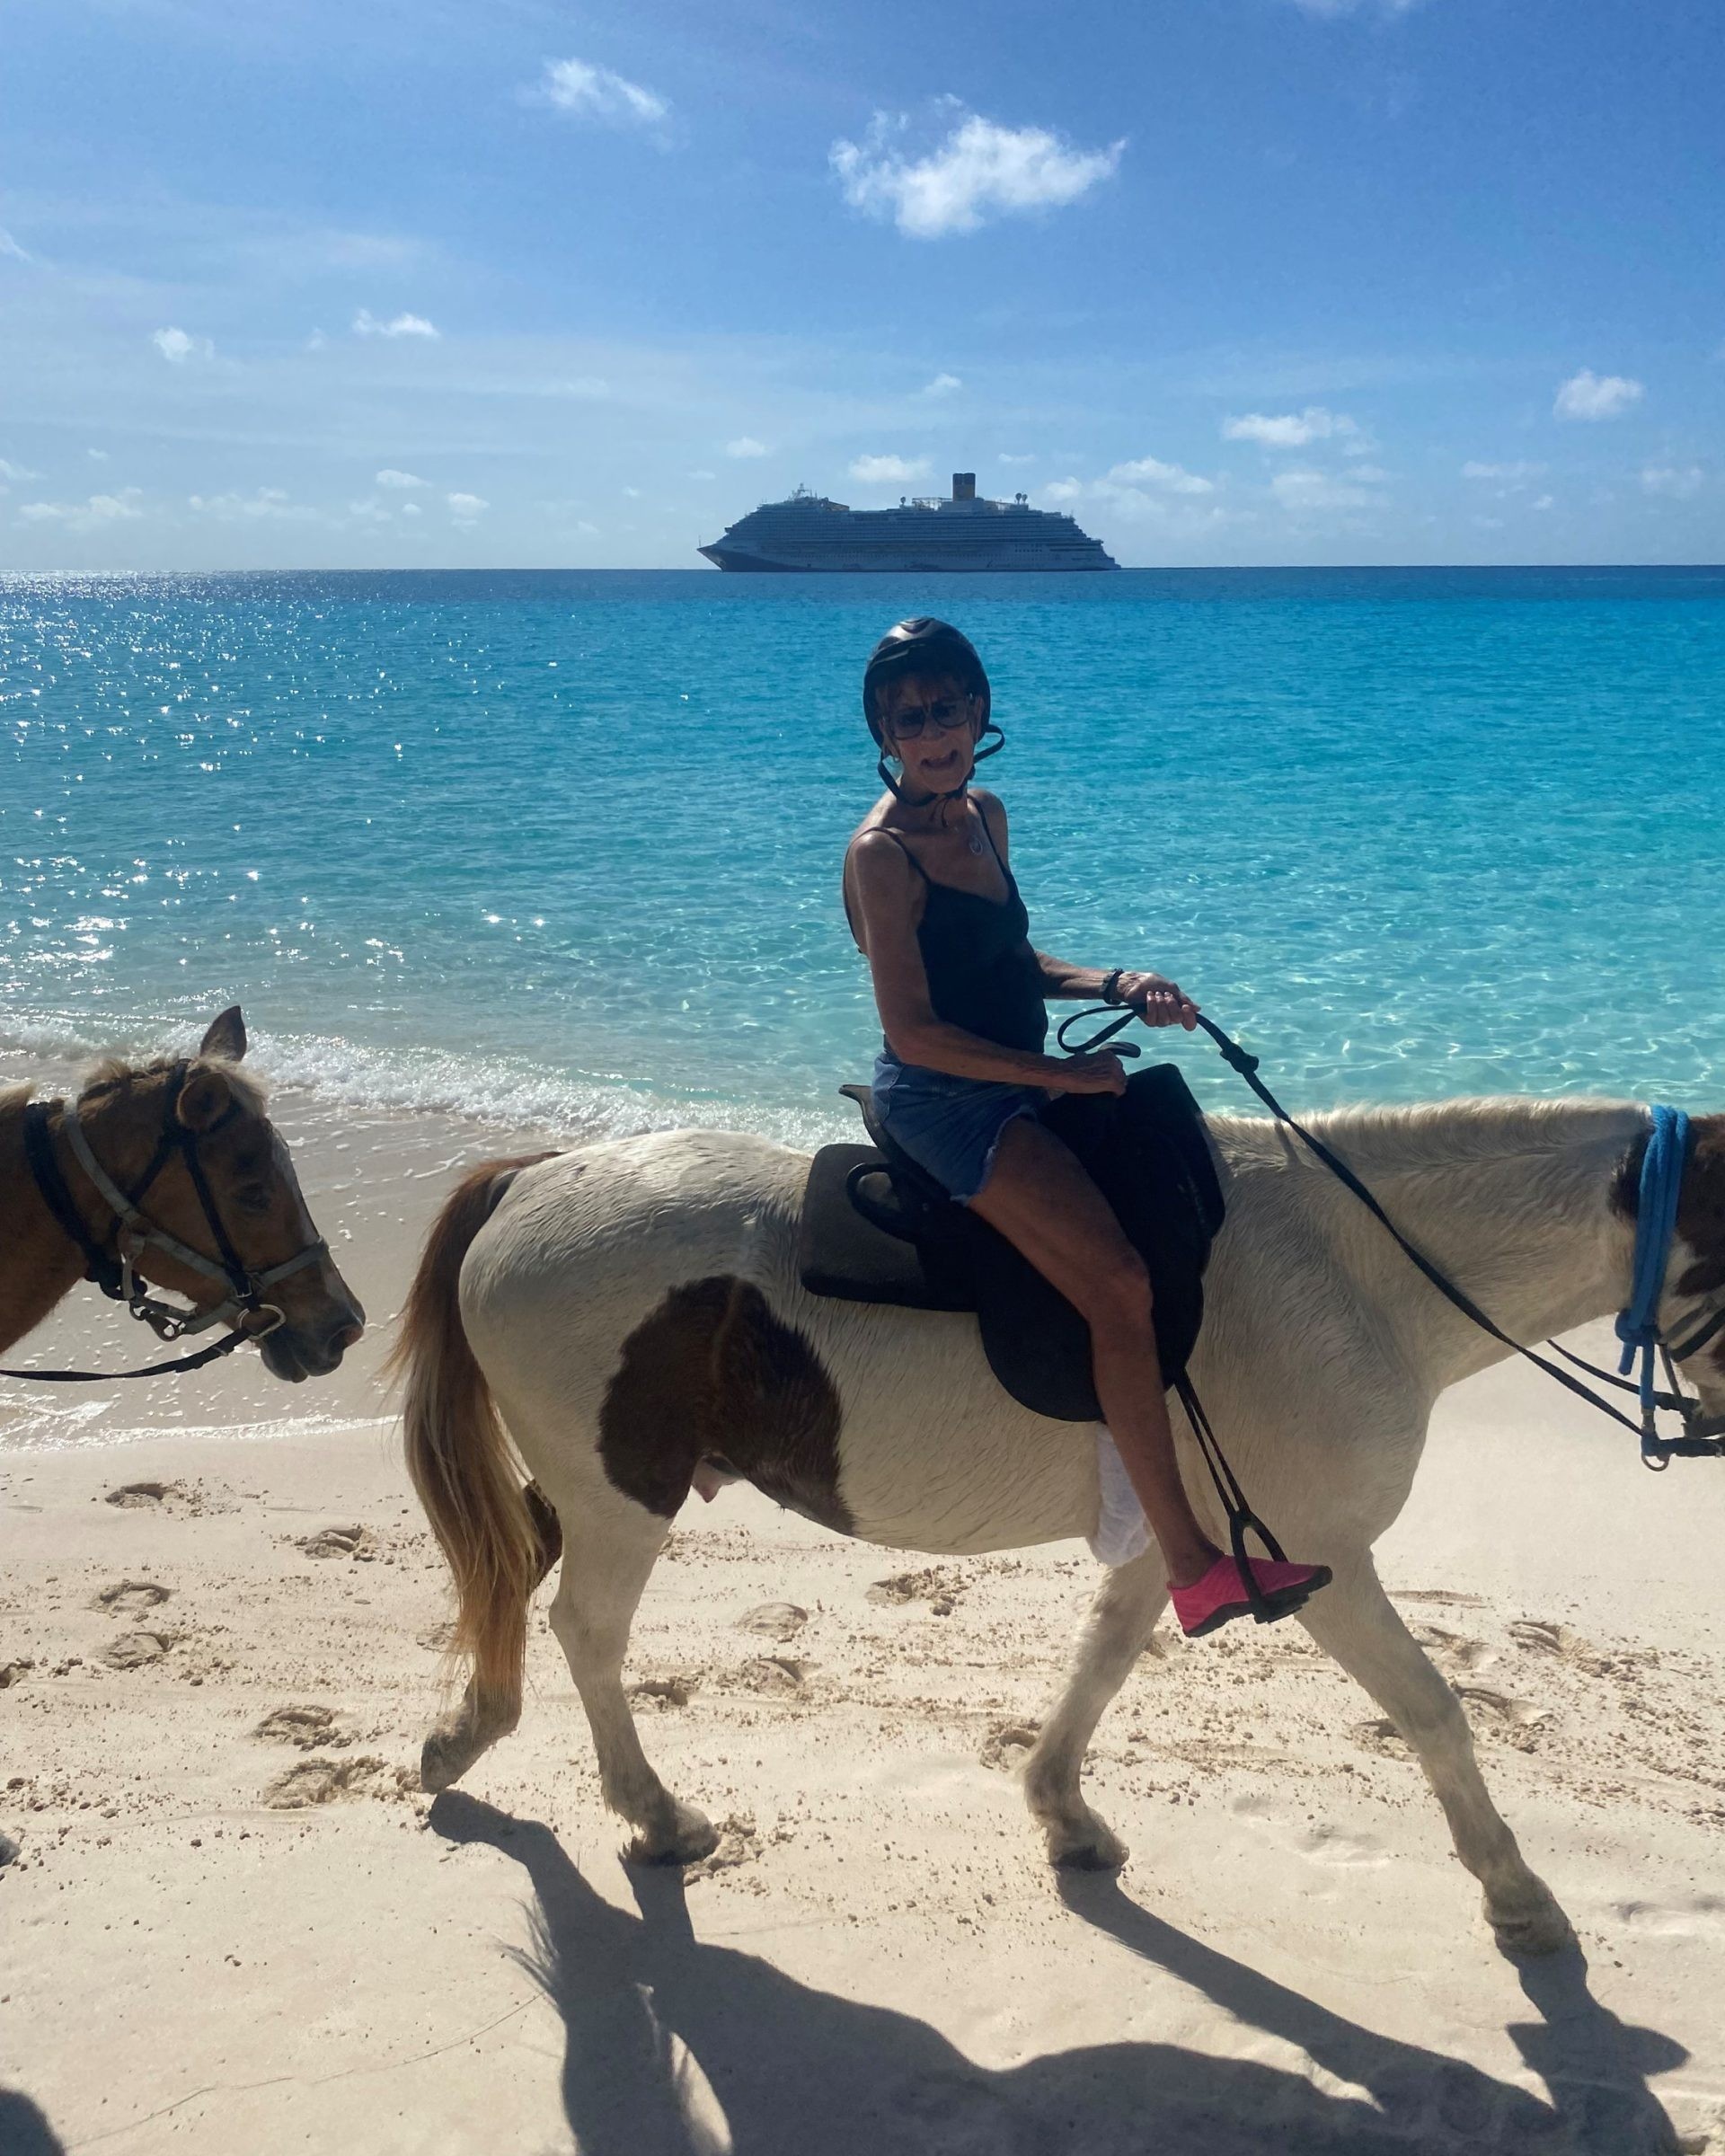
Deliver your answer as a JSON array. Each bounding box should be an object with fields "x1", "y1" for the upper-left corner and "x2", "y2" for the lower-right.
[{"x1": 845, "y1": 616, "x2": 1331, "y2": 1634}]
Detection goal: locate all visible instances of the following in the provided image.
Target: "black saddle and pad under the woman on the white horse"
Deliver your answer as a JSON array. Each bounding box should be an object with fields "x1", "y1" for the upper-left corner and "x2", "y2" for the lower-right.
[{"x1": 798, "y1": 1063, "x2": 1223, "y2": 1423}]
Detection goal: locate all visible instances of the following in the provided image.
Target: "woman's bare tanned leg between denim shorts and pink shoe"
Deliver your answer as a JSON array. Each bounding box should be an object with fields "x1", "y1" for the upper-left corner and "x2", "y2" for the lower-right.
[{"x1": 970, "y1": 1117, "x2": 1220, "y2": 1586}]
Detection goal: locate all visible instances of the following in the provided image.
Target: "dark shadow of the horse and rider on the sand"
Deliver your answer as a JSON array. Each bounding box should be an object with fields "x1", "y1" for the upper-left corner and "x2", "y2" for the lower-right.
[{"x1": 429, "y1": 1791, "x2": 1686, "y2": 2156}]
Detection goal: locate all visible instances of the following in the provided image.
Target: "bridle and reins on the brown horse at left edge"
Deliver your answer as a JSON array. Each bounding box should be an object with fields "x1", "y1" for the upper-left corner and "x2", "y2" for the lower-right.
[{"x1": 0, "y1": 1058, "x2": 330, "y2": 1384}]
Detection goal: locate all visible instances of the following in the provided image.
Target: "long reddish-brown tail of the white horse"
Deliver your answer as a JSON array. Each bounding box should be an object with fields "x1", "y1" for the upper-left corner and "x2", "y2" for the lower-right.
[{"x1": 386, "y1": 1153, "x2": 559, "y2": 1701}]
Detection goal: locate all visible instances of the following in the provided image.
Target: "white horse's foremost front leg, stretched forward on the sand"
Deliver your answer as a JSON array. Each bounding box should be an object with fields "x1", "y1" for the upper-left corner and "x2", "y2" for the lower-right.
[{"x1": 1300, "y1": 1552, "x2": 1570, "y2": 1953}]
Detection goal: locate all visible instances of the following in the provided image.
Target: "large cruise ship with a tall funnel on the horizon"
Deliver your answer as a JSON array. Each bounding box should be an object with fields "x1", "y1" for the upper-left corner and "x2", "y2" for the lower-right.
[{"x1": 699, "y1": 473, "x2": 1119, "y2": 576}]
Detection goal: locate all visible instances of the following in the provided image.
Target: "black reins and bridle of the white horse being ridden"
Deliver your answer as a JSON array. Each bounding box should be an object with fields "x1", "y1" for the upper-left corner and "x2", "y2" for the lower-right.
[{"x1": 1057, "y1": 1007, "x2": 1725, "y2": 1472}]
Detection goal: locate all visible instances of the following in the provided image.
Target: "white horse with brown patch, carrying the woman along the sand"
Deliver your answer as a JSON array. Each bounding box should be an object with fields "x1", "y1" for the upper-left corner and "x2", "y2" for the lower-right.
[{"x1": 397, "y1": 1100, "x2": 1725, "y2": 1949}]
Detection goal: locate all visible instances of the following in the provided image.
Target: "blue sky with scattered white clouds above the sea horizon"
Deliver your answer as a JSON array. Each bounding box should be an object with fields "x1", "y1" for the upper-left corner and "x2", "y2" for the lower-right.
[{"x1": 0, "y1": 0, "x2": 1725, "y2": 570}]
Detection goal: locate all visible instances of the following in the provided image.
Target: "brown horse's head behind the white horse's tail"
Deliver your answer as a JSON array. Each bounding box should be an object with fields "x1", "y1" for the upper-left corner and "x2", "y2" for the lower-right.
[{"x1": 77, "y1": 1004, "x2": 365, "y2": 1384}]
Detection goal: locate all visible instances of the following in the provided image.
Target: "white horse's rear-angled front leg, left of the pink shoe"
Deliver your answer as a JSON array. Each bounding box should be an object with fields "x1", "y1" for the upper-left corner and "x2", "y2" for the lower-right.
[{"x1": 1024, "y1": 1543, "x2": 1169, "y2": 1871}]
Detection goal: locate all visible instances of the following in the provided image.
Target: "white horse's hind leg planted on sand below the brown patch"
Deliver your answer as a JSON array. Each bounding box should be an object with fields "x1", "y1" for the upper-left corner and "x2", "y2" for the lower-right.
[{"x1": 552, "y1": 1492, "x2": 718, "y2": 1865}]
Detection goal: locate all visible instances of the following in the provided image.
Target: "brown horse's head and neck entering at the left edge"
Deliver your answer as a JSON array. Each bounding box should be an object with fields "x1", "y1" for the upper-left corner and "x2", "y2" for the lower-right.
[{"x1": 0, "y1": 1004, "x2": 365, "y2": 1384}]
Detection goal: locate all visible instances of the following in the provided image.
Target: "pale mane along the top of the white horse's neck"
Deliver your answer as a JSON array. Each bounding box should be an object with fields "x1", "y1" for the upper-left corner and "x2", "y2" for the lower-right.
[{"x1": 1209, "y1": 1093, "x2": 1648, "y2": 1175}]
